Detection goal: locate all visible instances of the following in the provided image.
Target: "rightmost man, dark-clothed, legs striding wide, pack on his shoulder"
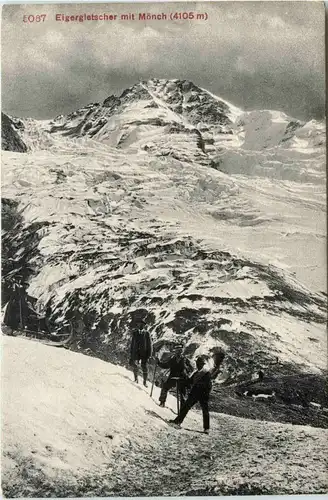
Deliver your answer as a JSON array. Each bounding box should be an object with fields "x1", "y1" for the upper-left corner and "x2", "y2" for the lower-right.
[{"x1": 169, "y1": 351, "x2": 225, "y2": 434}]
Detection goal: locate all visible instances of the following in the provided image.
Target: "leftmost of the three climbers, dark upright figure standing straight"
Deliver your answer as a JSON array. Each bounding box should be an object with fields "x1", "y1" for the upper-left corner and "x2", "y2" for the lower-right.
[{"x1": 130, "y1": 329, "x2": 152, "y2": 387}]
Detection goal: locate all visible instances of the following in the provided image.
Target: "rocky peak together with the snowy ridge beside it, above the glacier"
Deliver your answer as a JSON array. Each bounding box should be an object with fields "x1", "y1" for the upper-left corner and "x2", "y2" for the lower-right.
[{"x1": 7, "y1": 78, "x2": 325, "y2": 178}]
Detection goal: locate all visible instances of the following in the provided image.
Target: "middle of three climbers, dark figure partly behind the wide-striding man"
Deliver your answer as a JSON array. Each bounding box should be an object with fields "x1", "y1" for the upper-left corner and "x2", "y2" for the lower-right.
[{"x1": 156, "y1": 344, "x2": 192, "y2": 407}]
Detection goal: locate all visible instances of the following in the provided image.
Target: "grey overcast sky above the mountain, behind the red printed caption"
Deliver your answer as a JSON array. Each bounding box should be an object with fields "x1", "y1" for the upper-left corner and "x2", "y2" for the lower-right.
[{"x1": 2, "y1": 2, "x2": 324, "y2": 119}]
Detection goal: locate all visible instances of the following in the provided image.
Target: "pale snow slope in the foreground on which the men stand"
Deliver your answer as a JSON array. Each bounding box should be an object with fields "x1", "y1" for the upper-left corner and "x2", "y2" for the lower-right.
[{"x1": 2, "y1": 337, "x2": 328, "y2": 497}]
